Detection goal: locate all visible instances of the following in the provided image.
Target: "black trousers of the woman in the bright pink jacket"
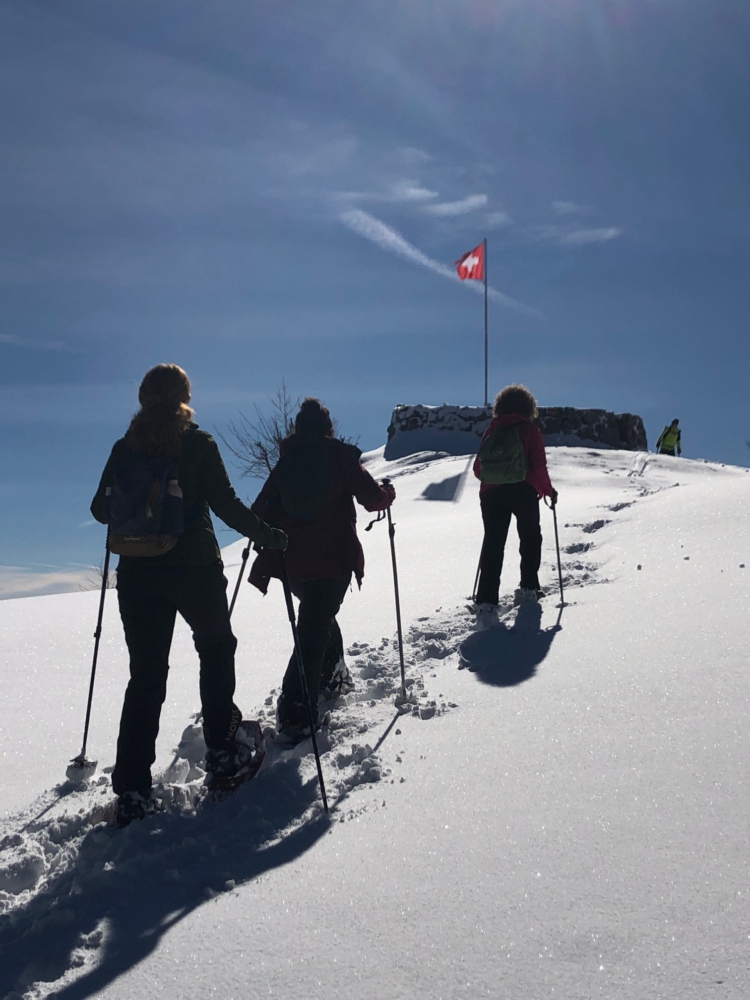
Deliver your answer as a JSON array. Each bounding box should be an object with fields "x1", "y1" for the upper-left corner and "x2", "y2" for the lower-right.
[{"x1": 476, "y1": 482, "x2": 542, "y2": 604}]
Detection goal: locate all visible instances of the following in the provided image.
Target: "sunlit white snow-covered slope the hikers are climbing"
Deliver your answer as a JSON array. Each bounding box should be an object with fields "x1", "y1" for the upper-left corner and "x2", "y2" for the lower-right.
[{"x1": 0, "y1": 448, "x2": 750, "y2": 1000}]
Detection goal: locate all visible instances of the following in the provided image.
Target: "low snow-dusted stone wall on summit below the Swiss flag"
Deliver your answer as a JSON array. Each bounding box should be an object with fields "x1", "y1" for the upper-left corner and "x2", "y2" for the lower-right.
[{"x1": 385, "y1": 403, "x2": 648, "y2": 460}]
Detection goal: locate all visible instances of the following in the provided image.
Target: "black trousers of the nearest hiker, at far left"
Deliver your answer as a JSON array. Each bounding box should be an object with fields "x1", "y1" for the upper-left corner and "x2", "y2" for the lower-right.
[{"x1": 112, "y1": 560, "x2": 239, "y2": 796}]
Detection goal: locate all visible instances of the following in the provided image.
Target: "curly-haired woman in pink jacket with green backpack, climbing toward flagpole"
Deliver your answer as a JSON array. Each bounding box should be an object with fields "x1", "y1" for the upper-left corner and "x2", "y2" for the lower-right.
[{"x1": 474, "y1": 385, "x2": 557, "y2": 607}]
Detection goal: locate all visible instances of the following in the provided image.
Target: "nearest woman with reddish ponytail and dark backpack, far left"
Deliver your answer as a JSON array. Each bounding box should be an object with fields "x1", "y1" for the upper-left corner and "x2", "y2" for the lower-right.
[{"x1": 91, "y1": 364, "x2": 287, "y2": 826}]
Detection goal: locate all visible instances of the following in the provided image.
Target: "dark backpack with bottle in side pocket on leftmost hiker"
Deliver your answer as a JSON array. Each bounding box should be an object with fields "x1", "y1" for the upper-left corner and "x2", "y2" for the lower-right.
[{"x1": 109, "y1": 448, "x2": 184, "y2": 557}]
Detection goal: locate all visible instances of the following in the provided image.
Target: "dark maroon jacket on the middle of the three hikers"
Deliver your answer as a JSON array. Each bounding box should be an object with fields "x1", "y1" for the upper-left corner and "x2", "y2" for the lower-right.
[{"x1": 250, "y1": 435, "x2": 395, "y2": 594}]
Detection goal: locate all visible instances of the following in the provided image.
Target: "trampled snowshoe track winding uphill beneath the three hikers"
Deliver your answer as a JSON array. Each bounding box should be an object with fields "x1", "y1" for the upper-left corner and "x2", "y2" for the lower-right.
[{"x1": 0, "y1": 450, "x2": 656, "y2": 989}]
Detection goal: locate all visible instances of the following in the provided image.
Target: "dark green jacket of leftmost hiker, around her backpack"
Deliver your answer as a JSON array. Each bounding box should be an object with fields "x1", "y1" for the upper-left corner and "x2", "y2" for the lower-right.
[{"x1": 91, "y1": 423, "x2": 282, "y2": 569}]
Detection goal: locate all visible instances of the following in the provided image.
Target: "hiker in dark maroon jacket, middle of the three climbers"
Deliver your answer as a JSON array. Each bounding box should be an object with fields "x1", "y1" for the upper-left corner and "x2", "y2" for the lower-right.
[{"x1": 250, "y1": 398, "x2": 396, "y2": 742}]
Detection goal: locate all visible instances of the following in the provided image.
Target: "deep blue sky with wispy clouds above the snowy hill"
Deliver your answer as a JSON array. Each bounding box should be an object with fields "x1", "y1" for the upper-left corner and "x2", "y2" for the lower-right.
[{"x1": 0, "y1": 0, "x2": 750, "y2": 594}]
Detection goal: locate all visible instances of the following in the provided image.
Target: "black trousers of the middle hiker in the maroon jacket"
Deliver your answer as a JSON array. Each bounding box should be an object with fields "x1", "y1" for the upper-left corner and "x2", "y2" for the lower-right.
[{"x1": 279, "y1": 573, "x2": 352, "y2": 726}]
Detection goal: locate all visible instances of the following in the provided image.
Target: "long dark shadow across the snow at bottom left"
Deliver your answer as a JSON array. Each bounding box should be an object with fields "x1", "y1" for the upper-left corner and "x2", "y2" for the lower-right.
[{"x1": 0, "y1": 759, "x2": 330, "y2": 1000}]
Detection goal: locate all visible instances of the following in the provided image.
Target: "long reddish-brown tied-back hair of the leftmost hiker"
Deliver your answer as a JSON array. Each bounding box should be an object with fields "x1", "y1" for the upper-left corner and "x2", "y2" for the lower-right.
[{"x1": 125, "y1": 365, "x2": 193, "y2": 458}]
